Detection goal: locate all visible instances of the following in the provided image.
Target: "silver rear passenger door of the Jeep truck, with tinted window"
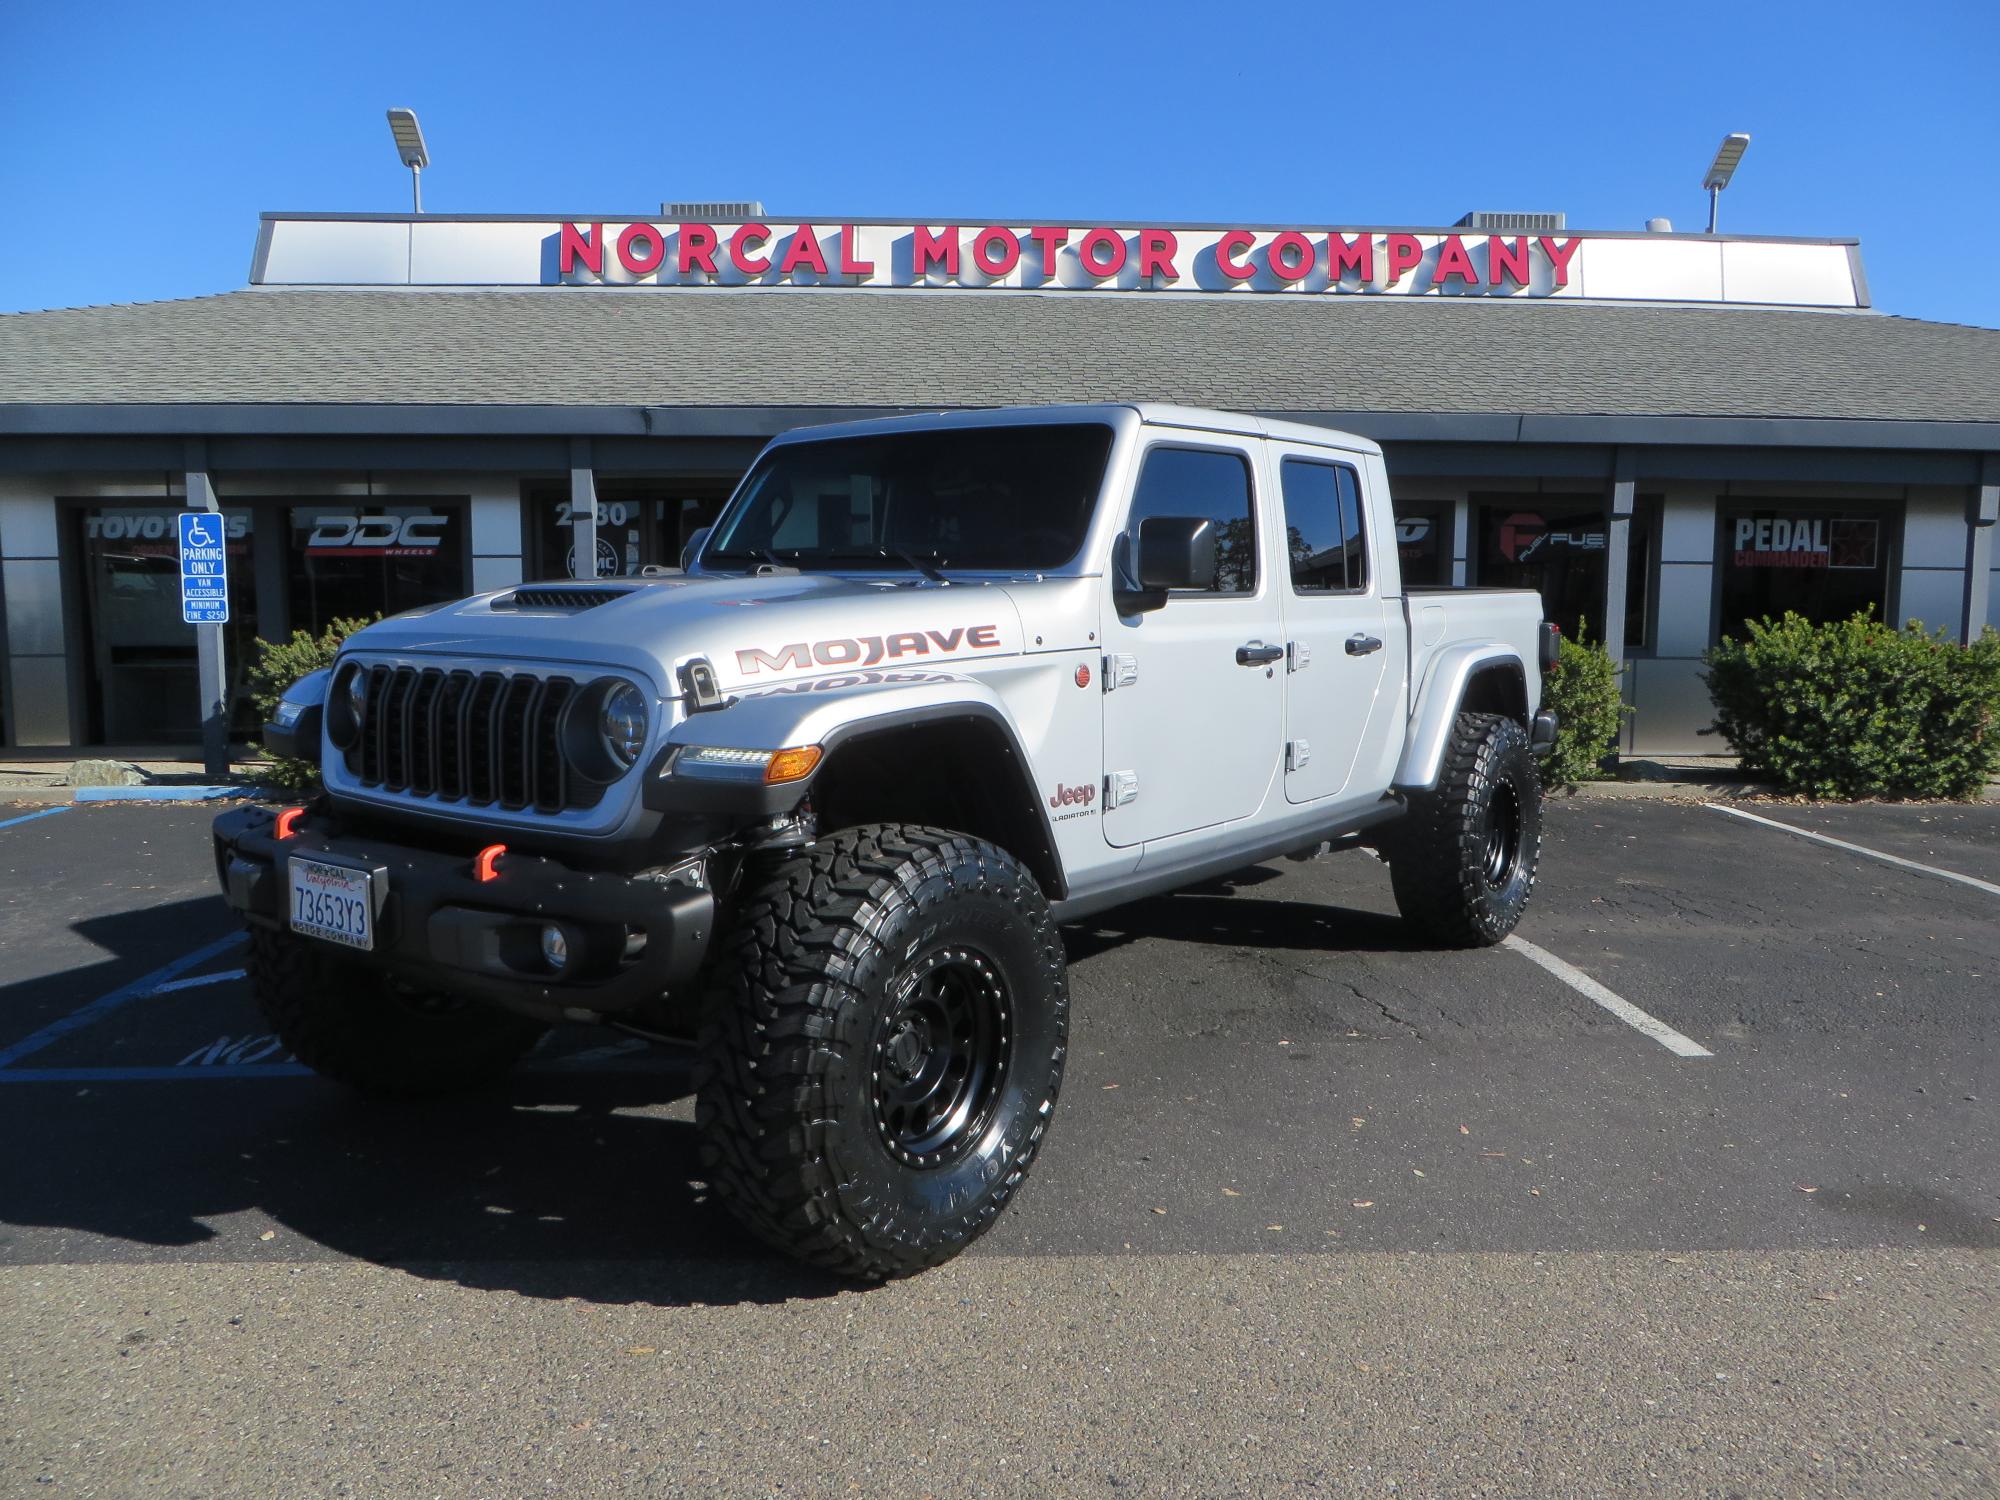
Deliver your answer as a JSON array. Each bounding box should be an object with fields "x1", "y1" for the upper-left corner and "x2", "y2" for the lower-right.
[{"x1": 1270, "y1": 444, "x2": 1408, "y2": 802}]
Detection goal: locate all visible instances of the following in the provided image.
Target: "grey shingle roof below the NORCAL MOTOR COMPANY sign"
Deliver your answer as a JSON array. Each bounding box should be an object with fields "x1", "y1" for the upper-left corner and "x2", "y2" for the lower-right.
[{"x1": 0, "y1": 290, "x2": 2000, "y2": 422}]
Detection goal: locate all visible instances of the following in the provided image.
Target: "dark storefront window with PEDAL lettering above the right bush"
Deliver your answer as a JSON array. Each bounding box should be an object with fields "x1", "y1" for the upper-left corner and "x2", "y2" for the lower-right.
[{"x1": 1722, "y1": 502, "x2": 1890, "y2": 638}]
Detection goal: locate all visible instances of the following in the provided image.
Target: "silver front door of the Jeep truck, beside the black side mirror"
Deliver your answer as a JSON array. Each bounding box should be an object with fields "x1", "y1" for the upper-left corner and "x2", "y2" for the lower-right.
[{"x1": 1102, "y1": 434, "x2": 1284, "y2": 848}]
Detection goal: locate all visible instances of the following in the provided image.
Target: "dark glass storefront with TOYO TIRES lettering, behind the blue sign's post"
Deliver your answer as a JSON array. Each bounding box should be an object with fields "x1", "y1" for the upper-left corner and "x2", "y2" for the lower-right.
[{"x1": 78, "y1": 506, "x2": 258, "y2": 744}]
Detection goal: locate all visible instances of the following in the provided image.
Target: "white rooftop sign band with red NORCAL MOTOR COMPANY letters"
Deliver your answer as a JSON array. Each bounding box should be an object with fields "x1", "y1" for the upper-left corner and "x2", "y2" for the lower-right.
[{"x1": 250, "y1": 214, "x2": 1864, "y2": 306}]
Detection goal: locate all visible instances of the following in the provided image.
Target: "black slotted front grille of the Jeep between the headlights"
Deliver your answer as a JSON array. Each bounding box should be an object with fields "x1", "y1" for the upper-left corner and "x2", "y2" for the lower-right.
[{"x1": 346, "y1": 666, "x2": 604, "y2": 812}]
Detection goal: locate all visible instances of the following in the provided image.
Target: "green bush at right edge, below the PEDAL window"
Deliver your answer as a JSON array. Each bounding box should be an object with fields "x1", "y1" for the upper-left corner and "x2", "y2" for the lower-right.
[{"x1": 1706, "y1": 610, "x2": 2000, "y2": 800}]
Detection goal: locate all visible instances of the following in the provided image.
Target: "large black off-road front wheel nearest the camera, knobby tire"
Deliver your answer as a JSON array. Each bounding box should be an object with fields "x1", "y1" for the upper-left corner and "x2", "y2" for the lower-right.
[{"x1": 696, "y1": 824, "x2": 1070, "y2": 1280}]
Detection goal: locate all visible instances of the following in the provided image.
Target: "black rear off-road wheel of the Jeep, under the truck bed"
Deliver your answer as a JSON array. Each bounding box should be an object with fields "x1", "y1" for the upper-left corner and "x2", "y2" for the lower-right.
[{"x1": 1384, "y1": 714, "x2": 1542, "y2": 948}]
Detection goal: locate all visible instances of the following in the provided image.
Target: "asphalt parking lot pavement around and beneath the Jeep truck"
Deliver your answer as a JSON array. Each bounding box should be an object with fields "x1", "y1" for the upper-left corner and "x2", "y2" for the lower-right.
[{"x1": 0, "y1": 798, "x2": 2000, "y2": 1496}]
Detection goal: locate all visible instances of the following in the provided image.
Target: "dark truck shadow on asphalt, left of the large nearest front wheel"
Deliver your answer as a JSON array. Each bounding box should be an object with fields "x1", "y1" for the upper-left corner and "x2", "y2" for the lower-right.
[{"x1": 0, "y1": 1054, "x2": 846, "y2": 1306}]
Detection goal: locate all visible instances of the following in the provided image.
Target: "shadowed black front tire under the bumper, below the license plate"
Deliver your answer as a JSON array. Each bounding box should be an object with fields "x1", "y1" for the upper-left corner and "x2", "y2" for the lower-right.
[{"x1": 246, "y1": 928, "x2": 548, "y2": 1098}]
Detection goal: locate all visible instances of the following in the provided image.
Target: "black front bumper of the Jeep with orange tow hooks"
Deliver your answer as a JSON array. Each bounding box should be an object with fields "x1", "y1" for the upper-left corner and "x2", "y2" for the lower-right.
[{"x1": 214, "y1": 808, "x2": 716, "y2": 1020}]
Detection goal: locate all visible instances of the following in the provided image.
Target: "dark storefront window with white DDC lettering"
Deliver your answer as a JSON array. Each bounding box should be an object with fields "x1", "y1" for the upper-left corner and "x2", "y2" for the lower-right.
[{"x1": 286, "y1": 500, "x2": 466, "y2": 632}]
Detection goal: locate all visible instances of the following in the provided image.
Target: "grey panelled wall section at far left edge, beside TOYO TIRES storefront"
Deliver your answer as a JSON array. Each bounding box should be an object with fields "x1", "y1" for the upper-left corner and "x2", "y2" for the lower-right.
[{"x1": 0, "y1": 476, "x2": 76, "y2": 746}]
